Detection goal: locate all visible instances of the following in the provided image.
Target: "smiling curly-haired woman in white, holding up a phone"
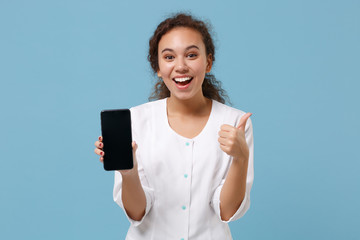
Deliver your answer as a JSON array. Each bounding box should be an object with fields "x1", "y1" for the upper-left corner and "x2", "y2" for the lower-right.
[{"x1": 95, "y1": 14, "x2": 253, "y2": 240}]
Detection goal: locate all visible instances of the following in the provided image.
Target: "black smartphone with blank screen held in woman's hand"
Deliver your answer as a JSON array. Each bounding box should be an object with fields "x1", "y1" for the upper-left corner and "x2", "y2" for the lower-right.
[{"x1": 101, "y1": 109, "x2": 134, "y2": 171}]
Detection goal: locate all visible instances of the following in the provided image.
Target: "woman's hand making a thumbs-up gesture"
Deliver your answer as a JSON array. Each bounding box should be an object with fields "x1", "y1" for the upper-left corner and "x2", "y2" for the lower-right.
[{"x1": 218, "y1": 113, "x2": 252, "y2": 161}]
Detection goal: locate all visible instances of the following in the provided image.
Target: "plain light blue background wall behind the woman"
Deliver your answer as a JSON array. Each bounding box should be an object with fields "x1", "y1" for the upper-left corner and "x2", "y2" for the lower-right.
[{"x1": 0, "y1": 0, "x2": 360, "y2": 239}]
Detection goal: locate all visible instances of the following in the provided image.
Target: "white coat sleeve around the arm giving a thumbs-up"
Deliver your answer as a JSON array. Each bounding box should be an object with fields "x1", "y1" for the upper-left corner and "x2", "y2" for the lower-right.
[{"x1": 211, "y1": 118, "x2": 254, "y2": 223}]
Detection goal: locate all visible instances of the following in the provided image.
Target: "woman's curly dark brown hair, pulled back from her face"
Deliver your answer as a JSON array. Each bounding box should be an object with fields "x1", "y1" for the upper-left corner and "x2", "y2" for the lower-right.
[{"x1": 148, "y1": 13, "x2": 229, "y2": 103}]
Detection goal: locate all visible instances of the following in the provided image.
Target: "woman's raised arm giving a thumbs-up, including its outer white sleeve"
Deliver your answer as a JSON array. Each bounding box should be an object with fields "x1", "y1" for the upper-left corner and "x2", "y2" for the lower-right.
[{"x1": 219, "y1": 113, "x2": 253, "y2": 221}]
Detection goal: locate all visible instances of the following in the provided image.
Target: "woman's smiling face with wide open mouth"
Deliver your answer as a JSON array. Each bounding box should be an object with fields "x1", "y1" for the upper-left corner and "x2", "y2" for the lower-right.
[{"x1": 157, "y1": 27, "x2": 212, "y2": 100}]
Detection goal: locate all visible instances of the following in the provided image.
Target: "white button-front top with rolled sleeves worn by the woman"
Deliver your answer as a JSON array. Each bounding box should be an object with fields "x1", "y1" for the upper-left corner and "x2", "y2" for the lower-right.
[{"x1": 114, "y1": 99, "x2": 254, "y2": 240}]
